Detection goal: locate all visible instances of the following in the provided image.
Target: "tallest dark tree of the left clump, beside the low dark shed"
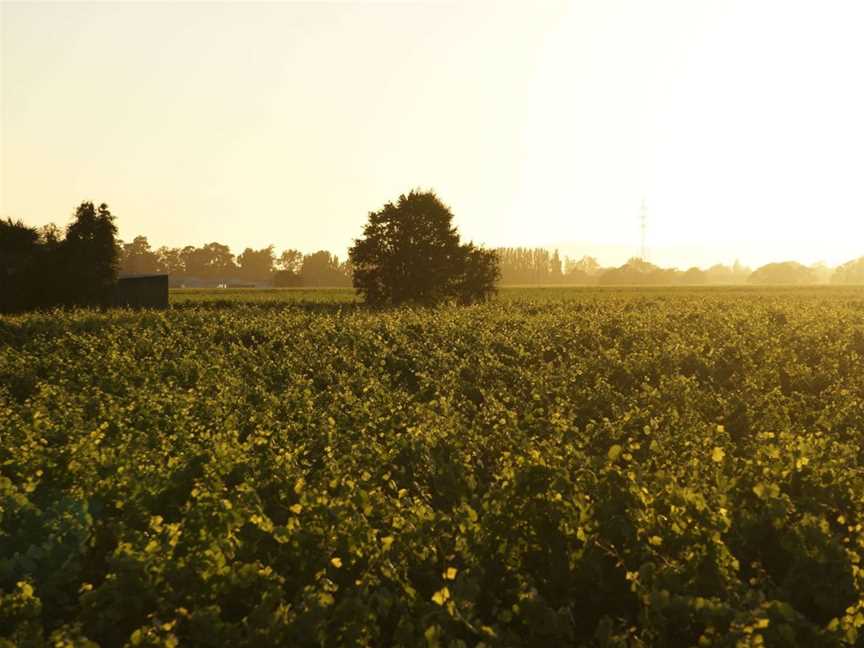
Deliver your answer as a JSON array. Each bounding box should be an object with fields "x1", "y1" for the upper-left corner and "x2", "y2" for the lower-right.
[{"x1": 58, "y1": 202, "x2": 119, "y2": 306}]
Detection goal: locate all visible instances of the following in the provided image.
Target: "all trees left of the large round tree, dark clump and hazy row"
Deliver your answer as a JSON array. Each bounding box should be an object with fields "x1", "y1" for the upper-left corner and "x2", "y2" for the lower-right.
[{"x1": 0, "y1": 201, "x2": 352, "y2": 312}]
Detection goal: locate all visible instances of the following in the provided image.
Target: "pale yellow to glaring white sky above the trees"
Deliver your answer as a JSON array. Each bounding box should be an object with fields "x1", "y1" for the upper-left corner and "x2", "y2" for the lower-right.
[{"x1": 0, "y1": 0, "x2": 864, "y2": 267}]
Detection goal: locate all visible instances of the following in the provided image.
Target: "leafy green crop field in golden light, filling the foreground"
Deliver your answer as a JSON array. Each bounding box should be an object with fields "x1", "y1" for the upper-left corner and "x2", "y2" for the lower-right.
[{"x1": 0, "y1": 288, "x2": 864, "y2": 648}]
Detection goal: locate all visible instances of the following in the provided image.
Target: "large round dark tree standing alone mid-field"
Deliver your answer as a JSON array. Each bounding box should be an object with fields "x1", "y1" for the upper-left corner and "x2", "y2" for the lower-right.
[{"x1": 348, "y1": 190, "x2": 499, "y2": 306}]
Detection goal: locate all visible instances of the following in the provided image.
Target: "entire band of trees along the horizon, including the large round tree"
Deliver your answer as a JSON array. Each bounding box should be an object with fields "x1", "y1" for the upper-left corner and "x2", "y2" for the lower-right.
[{"x1": 0, "y1": 191, "x2": 864, "y2": 312}]
